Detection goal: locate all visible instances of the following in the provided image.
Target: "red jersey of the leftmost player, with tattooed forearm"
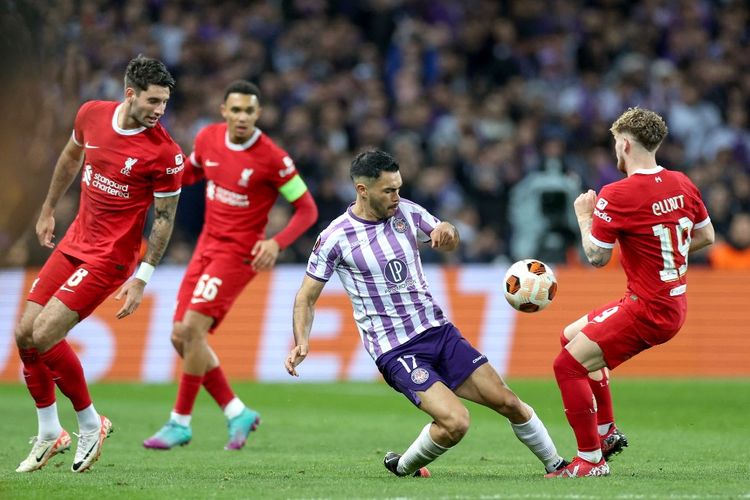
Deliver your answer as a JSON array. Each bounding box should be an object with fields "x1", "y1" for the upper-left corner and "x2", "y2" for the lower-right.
[{"x1": 59, "y1": 101, "x2": 185, "y2": 275}]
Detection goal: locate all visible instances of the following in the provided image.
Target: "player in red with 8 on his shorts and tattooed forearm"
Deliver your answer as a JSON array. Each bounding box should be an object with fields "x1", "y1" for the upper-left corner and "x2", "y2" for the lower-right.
[{"x1": 15, "y1": 56, "x2": 184, "y2": 472}]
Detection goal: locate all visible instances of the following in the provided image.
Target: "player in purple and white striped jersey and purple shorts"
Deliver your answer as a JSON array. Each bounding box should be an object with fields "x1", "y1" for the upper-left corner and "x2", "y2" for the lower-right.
[{"x1": 285, "y1": 150, "x2": 566, "y2": 477}]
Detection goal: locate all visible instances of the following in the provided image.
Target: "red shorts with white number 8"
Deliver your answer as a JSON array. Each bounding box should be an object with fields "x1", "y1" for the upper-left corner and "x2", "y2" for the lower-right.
[{"x1": 27, "y1": 249, "x2": 128, "y2": 320}]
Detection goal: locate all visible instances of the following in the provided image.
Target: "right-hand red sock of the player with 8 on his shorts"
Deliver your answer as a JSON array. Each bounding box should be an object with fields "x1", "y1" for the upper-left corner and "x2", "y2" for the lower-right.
[{"x1": 40, "y1": 340, "x2": 91, "y2": 411}]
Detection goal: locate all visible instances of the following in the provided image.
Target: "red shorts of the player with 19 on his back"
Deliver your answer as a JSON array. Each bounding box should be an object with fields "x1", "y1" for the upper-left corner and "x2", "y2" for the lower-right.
[{"x1": 581, "y1": 294, "x2": 682, "y2": 369}]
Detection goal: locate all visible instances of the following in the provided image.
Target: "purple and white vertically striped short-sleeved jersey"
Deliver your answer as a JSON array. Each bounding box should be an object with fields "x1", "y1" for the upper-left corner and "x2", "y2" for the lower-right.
[{"x1": 307, "y1": 198, "x2": 448, "y2": 359}]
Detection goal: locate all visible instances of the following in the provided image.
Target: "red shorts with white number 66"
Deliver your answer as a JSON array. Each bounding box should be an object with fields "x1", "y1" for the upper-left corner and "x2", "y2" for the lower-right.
[{"x1": 174, "y1": 249, "x2": 257, "y2": 332}]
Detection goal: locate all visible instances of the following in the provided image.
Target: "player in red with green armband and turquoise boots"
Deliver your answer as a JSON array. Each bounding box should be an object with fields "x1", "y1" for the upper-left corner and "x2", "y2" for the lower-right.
[{"x1": 143, "y1": 80, "x2": 318, "y2": 450}]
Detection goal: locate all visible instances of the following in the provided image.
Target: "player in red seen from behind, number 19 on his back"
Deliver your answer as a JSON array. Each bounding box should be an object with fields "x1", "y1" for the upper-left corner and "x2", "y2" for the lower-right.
[{"x1": 547, "y1": 108, "x2": 714, "y2": 477}]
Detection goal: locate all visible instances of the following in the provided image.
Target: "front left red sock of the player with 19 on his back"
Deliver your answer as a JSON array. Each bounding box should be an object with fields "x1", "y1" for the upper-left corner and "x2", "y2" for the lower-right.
[{"x1": 553, "y1": 349, "x2": 601, "y2": 451}]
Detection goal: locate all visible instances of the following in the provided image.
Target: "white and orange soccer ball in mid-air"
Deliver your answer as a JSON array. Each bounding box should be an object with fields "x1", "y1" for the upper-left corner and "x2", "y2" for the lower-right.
[{"x1": 503, "y1": 259, "x2": 557, "y2": 313}]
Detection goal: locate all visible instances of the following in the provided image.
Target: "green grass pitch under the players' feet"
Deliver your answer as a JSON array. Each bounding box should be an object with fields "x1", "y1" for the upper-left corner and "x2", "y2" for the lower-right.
[{"x1": 0, "y1": 380, "x2": 750, "y2": 500}]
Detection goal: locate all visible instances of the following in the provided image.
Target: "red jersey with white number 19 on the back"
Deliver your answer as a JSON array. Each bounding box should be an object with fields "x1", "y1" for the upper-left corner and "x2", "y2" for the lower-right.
[{"x1": 591, "y1": 167, "x2": 710, "y2": 324}]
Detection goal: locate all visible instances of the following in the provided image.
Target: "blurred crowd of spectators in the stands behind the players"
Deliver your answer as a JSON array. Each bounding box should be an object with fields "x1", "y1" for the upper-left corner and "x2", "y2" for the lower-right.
[{"x1": 0, "y1": 0, "x2": 750, "y2": 268}]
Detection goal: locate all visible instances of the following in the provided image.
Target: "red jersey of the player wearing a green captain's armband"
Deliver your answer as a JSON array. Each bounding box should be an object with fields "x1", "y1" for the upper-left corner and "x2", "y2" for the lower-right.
[{"x1": 186, "y1": 123, "x2": 307, "y2": 256}]
